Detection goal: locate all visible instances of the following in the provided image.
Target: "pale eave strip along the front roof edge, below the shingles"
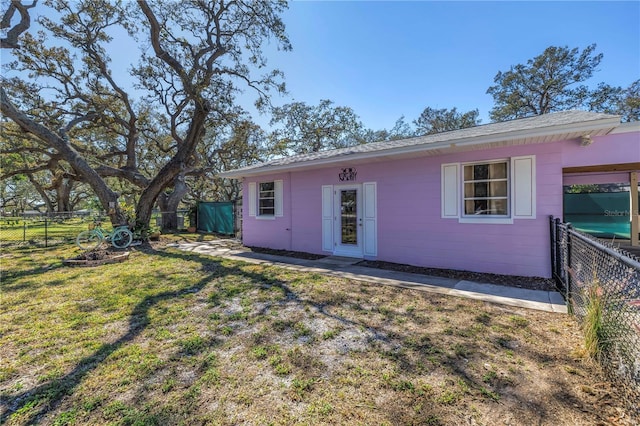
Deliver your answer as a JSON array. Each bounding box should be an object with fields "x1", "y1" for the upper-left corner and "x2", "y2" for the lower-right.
[{"x1": 218, "y1": 116, "x2": 620, "y2": 179}]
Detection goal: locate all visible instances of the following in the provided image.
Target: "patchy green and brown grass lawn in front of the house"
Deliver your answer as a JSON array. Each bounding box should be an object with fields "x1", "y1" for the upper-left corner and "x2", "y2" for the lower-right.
[{"x1": 0, "y1": 241, "x2": 631, "y2": 425}]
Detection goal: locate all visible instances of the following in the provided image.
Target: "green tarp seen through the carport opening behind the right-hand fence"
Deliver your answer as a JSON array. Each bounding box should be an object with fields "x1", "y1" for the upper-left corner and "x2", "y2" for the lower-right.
[{"x1": 564, "y1": 192, "x2": 631, "y2": 239}]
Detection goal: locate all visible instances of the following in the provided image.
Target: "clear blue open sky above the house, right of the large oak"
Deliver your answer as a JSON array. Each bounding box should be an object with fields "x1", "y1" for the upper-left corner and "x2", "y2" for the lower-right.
[{"x1": 255, "y1": 1, "x2": 640, "y2": 129}]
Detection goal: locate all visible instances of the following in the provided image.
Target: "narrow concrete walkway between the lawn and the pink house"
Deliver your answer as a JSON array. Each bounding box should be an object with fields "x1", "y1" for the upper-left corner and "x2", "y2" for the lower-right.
[{"x1": 170, "y1": 240, "x2": 567, "y2": 313}]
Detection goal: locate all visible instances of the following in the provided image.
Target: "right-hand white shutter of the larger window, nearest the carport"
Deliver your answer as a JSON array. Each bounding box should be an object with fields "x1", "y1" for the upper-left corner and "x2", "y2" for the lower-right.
[{"x1": 511, "y1": 155, "x2": 536, "y2": 219}]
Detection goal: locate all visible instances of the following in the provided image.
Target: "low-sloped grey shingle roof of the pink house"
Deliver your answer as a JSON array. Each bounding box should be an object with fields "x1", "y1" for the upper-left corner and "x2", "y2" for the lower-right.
[{"x1": 221, "y1": 111, "x2": 619, "y2": 177}]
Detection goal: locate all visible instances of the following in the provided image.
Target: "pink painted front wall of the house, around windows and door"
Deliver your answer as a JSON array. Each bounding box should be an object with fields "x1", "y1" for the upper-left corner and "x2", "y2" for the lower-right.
[{"x1": 243, "y1": 133, "x2": 640, "y2": 277}]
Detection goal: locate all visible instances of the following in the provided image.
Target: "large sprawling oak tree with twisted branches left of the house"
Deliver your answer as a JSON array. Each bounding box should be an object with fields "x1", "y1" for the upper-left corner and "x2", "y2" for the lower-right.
[{"x1": 0, "y1": 0, "x2": 290, "y2": 228}]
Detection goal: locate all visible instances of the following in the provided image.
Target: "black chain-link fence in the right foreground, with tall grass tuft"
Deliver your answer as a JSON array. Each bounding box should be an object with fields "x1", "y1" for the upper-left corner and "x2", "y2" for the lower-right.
[{"x1": 551, "y1": 217, "x2": 640, "y2": 414}]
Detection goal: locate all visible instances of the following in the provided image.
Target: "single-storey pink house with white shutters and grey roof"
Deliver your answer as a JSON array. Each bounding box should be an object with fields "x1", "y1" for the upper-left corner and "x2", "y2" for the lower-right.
[{"x1": 222, "y1": 111, "x2": 640, "y2": 277}]
